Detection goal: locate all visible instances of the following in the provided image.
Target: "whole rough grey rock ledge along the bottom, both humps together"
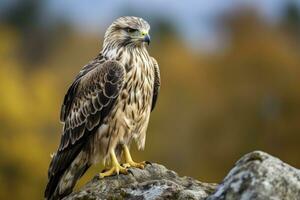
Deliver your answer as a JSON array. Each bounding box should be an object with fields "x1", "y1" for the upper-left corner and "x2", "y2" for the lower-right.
[{"x1": 64, "y1": 151, "x2": 300, "y2": 200}]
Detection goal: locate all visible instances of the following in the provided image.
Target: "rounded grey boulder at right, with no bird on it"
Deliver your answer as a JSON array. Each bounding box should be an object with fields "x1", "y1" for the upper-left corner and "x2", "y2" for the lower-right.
[{"x1": 207, "y1": 151, "x2": 300, "y2": 200}]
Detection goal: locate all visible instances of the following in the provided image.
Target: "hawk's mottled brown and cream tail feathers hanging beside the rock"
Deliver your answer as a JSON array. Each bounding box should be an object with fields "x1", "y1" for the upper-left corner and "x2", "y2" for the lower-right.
[{"x1": 45, "y1": 151, "x2": 90, "y2": 200}]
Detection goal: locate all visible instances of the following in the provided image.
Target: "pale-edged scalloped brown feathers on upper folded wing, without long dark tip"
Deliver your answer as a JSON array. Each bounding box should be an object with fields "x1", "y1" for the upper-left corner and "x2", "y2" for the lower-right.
[{"x1": 59, "y1": 61, "x2": 125, "y2": 151}]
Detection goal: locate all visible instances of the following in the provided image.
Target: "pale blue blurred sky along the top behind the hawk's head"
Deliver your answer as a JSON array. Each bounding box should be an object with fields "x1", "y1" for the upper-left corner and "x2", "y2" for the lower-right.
[{"x1": 0, "y1": 0, "x2": 300, "y2": 49}]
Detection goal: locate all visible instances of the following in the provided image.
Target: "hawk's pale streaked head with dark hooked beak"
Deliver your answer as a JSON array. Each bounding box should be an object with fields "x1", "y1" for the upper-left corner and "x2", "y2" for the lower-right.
[{"x1": 104, "y1": 16, "x2": 150, "y2": 47}]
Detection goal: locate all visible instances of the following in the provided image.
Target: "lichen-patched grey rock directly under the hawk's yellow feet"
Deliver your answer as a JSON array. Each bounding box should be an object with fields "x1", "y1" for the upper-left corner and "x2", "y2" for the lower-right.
[{"x1": 64, "y1": 163, "x2": 217, "y2": 200}]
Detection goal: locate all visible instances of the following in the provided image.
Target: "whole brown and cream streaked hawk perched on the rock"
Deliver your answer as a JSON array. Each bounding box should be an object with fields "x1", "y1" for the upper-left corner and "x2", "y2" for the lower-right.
[{"x1": 45, "y1": 16, "x2": 160, "y2": 200}]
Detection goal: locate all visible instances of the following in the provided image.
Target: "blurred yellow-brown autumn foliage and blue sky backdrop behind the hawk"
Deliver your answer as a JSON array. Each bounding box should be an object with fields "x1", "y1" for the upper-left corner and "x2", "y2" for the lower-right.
[{"x1": 0, "y1": 0, "x2": 300, "y2": 199}]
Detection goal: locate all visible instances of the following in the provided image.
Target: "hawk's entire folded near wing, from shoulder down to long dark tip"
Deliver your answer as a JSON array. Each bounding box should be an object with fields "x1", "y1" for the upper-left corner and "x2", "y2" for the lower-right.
[{"x1": 45, "y1": 61, "x2": 125, "y2": 196}]
